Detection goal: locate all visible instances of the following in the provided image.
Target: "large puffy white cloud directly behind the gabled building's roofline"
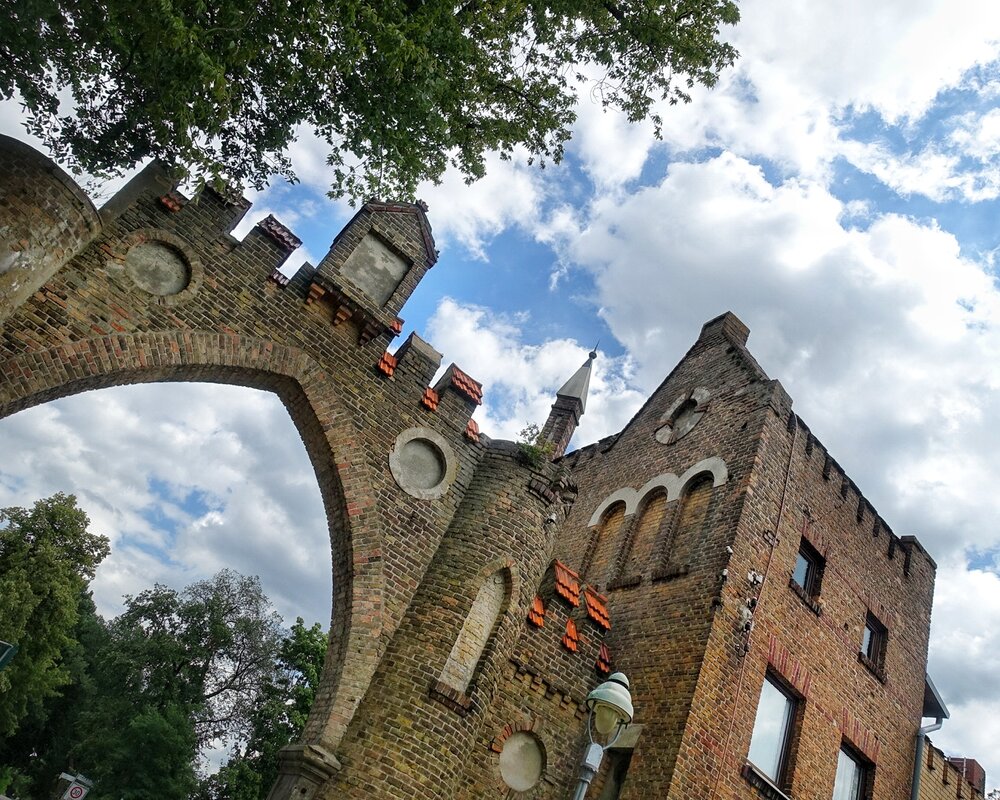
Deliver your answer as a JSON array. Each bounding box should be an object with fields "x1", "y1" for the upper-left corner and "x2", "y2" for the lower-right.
[{"x1": 562, "y1": 154, "x2": 1000, "y2": 568}]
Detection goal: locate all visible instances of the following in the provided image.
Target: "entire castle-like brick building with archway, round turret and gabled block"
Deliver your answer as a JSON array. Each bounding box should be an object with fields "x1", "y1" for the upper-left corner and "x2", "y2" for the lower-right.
[{"x1": 0, "y1": 134, "x2": 984, "y2": 800}]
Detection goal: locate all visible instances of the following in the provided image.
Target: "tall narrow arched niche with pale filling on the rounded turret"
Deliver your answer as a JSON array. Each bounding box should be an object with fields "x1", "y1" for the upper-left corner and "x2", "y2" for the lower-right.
[{"x1": 435, "y1": 568, "x2": 511, "y2": 710}]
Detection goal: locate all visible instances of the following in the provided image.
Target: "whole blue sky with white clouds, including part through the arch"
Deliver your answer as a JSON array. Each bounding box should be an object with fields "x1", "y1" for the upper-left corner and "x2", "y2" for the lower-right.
[{"x1": 0, "y1": 0, "x2": 1000, "y2": 783}]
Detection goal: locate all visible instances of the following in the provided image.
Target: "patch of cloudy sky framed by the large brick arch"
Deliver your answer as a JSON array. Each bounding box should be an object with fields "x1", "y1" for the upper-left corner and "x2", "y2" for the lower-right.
[{"x1": 0, "y1": 384, "x2": 331, "y2": 627}]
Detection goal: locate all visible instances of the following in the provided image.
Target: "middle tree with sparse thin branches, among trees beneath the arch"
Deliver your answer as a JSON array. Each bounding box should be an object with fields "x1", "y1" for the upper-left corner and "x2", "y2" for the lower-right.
[{"x1": 75, "y1": 570, "x2": 281, "y2": 800}]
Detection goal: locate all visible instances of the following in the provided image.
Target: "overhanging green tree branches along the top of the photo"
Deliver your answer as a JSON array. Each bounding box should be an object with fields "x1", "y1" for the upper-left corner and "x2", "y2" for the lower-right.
[{"x1": 0, "y1": 0, "x2": 739, "y2": 199}]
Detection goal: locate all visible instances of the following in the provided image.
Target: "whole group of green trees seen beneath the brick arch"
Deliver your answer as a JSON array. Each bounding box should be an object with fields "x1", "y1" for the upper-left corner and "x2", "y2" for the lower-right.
[{"x1": 0, "y1": 494, "x2": 326, "y2": 800}]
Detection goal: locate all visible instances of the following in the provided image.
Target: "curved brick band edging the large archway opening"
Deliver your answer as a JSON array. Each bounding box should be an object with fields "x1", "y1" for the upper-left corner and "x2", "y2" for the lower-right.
[{"x1": 0, "y1": 331, "x2": 384, "y2": 751}]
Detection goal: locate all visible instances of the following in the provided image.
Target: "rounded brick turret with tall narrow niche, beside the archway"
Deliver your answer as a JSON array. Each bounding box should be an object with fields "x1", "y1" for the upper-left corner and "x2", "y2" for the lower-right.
[{"x1": 325, "y1": 442, "x2": 559, "y2": 798}]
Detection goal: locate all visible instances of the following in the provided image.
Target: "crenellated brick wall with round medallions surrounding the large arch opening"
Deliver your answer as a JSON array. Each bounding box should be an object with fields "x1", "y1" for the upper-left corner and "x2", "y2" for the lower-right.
[{"x1": 0, "y1": 145, "x2": 484, "y2": 800}]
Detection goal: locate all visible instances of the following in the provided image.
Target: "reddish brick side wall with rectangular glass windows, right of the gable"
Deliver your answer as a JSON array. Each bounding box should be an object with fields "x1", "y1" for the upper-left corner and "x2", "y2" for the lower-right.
[{"x1": 664, "y1": 326, "x2": 935, "y2": 800}]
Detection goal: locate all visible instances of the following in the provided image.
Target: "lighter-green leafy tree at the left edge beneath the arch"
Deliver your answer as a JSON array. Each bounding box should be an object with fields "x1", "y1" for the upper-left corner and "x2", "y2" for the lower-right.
[{"x1": 0, "y1": 494, "x2": 109, "y2": 741}]
